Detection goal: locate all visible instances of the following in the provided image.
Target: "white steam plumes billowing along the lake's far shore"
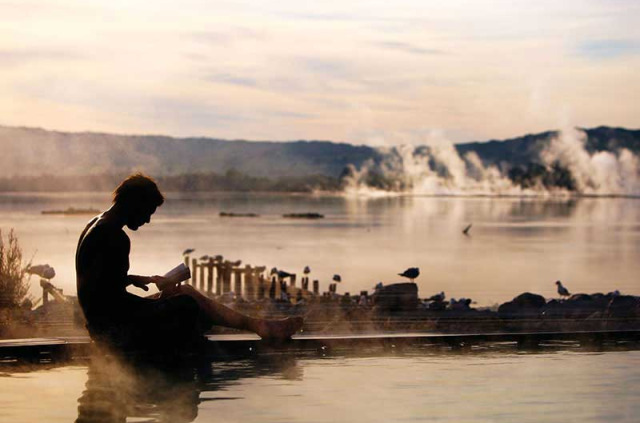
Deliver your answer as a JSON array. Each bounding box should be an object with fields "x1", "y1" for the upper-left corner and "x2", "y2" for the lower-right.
[{"x1": 344, "y1": 129, "x2": 640, "y2": 196}]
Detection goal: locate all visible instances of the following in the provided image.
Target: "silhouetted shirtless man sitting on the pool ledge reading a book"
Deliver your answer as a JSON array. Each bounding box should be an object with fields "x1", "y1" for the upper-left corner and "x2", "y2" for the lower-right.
[{"x1": 76, "y1": 174, "x2": 302, "y2": 344}]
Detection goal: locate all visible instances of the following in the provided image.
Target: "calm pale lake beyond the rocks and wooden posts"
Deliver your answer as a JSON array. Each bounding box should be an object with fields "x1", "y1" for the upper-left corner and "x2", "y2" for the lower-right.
[{"x1": 0, "y1": 193, "x2": 640, "y2": 305}]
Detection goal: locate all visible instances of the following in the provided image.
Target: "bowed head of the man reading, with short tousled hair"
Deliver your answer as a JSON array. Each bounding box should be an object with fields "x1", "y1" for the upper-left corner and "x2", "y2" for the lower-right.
[{"x1": 113, "y1": 173, "x2": 164, "y2": 231}]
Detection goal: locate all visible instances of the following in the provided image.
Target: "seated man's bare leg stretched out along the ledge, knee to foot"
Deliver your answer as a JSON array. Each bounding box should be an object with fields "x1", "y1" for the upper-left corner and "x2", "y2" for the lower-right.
[{"x1": 163, "y1": 285, "x2": 304, "y2": 338}]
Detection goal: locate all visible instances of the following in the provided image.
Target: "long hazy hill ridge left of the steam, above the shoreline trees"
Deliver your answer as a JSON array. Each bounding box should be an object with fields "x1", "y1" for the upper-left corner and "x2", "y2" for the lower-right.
[{"x1": 0, "y1": 126, "x2": 378, "y2": 178}]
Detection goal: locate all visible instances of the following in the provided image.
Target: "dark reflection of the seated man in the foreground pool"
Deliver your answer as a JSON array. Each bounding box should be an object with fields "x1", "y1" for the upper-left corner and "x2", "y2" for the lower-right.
[{"x1": 76, "y1": 354, "x2": 302, "y2": 423}]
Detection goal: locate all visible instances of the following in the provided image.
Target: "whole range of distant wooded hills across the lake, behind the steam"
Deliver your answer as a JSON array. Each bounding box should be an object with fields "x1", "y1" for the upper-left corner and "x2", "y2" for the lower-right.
[{"x1": 0, "y1": 126, "x2": 640, "y2": 191}]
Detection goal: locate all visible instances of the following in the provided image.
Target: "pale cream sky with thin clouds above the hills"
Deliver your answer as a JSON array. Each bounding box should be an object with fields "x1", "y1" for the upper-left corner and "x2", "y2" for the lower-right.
[{"x1": 0, "y1": 0, "x2": 640, "y2": 145}]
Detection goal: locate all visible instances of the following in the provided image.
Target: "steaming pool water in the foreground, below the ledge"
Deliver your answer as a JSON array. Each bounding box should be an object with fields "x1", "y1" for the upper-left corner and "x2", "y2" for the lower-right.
[{"x1": 0, "y1": 350, "x2": 640, "y2": 423}]
